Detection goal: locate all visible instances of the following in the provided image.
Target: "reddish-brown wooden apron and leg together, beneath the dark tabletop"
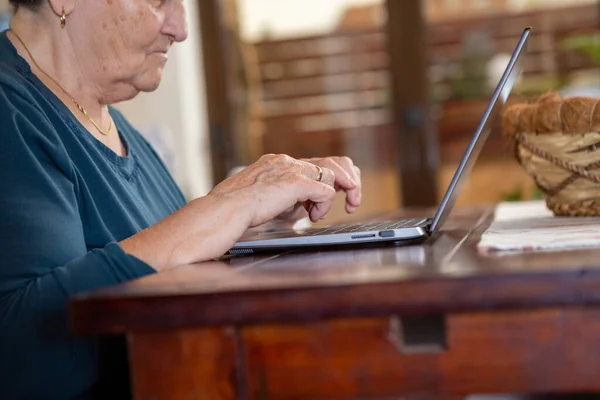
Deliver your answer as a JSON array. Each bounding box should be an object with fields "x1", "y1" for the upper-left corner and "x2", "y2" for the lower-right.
[{"x1": 123, "y1": 308, "x2": 600, "y2": 400}]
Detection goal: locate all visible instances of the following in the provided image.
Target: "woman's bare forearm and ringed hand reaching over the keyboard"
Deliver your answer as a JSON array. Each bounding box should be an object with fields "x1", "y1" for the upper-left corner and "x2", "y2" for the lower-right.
[{"x1": 121, "y1": 155, "x2": 344, "y2": 270}]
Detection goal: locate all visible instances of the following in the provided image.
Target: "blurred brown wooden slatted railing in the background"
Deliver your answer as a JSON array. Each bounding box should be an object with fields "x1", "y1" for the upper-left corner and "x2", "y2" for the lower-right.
[{"x1": 246, "y1": 5, "x2": 598, "y2": 165}]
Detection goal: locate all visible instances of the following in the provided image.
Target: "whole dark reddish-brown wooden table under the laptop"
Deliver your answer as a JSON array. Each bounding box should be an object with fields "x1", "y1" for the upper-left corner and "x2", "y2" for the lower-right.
[{"x1": 71, "y1": 208, "x2": 600, "y2": 400}]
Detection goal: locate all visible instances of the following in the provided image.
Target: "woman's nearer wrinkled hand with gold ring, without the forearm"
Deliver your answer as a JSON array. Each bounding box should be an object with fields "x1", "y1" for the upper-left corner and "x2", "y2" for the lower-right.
[{"x1": 209, "y1": 154, "x2": 340, "y2": 227}]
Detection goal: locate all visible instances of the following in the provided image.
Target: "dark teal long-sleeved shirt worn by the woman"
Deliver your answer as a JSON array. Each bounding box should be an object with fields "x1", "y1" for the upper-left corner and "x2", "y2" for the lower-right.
[{"x1": 0, "y1": 32, "x2": 185, "y2": 400}]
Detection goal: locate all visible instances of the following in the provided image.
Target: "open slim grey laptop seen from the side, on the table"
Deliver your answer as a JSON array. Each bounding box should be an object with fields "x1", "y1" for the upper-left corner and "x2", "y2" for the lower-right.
[{"x1": 229, "y1": 28, "x2": 531, "y2": 255}]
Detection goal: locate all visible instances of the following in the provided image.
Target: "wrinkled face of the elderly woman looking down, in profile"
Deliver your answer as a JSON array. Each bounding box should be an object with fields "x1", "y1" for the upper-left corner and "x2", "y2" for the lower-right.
[{"x1": 67, "y1": 0, "x2": 187, "y2": 95}]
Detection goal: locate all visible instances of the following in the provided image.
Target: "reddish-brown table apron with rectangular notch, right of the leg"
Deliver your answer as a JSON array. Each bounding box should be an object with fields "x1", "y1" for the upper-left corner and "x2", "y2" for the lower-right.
[{"x1": 244, "y1": 309, "x2": 600, "y2": 400}]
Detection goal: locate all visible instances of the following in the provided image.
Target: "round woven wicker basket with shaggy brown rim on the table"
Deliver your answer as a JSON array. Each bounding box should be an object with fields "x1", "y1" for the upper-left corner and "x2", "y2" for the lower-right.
[{"x1": 502, "y1": 93, "x2": 600, "y2": 216}]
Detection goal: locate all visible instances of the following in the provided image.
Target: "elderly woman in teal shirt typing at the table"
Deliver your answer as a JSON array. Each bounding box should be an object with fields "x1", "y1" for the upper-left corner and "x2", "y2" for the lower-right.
[{"x1": 0, "y1": 0, "x2": 360, "y2": 400}]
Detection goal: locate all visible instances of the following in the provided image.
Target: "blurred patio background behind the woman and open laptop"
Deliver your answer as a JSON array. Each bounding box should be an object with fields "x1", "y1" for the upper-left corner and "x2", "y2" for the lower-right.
[{"x1": 0, "y1": 0, "x2": 600, "y2": 223}]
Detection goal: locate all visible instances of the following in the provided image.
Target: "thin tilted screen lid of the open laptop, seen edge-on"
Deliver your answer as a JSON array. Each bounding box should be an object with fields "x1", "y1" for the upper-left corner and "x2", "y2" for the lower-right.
[{"x1": 430, "y1": 28, "x2": 531, "y2": 233}]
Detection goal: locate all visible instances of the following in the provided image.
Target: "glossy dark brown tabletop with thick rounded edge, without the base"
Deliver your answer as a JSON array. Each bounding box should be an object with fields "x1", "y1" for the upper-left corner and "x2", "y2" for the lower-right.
[{"x1": 71, "y1": 208, "x2": 600, "y2": 333}]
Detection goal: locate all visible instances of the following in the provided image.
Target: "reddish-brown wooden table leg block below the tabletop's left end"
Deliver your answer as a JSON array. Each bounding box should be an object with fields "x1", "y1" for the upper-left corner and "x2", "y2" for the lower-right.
[{"x1": 128, "y1": 328, "x2": 239, "y2": 400}]
